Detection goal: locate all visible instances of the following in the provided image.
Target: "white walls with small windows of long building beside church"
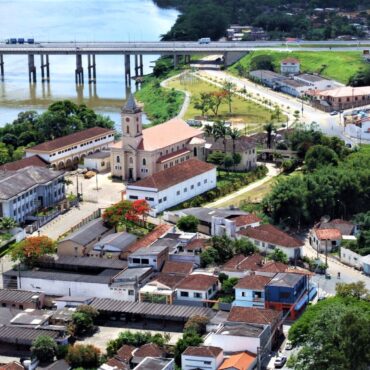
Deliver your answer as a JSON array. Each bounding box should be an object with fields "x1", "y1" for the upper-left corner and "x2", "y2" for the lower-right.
[{"x1": 126, "y1": 168, "x2": 217, "y2": 216}]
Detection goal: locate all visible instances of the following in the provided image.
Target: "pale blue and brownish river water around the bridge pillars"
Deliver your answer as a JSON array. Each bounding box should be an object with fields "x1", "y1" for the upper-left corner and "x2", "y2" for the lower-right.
[{"x1": 0, "y1": 0, "x2": 178, "y2": 126}]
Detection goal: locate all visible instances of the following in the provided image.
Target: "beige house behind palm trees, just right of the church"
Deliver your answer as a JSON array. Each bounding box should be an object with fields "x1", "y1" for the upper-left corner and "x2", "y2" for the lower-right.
[{"x1": 205, "y1": 136, "x2": 257, "y2": 171}]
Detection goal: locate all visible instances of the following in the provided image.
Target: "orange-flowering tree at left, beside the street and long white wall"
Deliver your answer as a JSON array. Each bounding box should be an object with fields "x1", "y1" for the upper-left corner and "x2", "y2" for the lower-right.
[{"x1": 11, "y1": 236, "x2": 56, "y2": 267}]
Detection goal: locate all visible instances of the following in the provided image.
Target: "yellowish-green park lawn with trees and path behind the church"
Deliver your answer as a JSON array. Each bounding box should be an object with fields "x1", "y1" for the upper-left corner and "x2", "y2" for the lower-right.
[{"x1": 167, "y1": 76, "x2": 278, "y2": 126}]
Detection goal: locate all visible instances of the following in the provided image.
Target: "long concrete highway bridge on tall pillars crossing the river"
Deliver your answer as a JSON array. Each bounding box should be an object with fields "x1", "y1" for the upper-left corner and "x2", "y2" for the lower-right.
[{"x1": 0, "y1": 40, "x2": 370, "y2": 85}]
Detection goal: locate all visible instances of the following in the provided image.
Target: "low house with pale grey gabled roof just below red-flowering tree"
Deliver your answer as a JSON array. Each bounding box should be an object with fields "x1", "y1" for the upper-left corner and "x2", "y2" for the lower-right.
[{"x1": 89, "y1": 231, "x2": 137, "y2": 258}]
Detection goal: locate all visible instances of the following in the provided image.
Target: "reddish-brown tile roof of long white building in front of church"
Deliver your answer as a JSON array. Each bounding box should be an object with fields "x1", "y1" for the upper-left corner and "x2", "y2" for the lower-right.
[{"x1": 127, "y1": 159, "x2": 216, "y2": 190}]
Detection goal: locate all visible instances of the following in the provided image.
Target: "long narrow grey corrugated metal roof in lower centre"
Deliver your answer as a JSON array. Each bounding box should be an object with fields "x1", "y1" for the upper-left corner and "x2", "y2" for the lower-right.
[{"x1": 90, "y1": 298, "x2": 214, "y2": 321}]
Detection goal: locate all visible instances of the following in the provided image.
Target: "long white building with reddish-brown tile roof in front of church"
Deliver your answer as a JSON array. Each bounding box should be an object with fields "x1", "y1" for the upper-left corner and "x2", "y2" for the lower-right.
[{"x1": 126, "y1": 159, "x2": 217, "y2": 216}]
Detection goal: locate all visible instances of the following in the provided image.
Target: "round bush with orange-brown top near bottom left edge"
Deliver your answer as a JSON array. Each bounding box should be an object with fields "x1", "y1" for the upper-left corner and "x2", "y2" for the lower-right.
[{"x1": 66, "y1": 344, "x2": 101, "y2": 369}]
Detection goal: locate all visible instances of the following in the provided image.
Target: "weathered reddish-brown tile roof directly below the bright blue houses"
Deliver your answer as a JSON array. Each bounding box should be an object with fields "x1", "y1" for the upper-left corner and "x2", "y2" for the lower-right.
[{"x1": 227, "y1": 306, "x2": 282, "y2": 326}]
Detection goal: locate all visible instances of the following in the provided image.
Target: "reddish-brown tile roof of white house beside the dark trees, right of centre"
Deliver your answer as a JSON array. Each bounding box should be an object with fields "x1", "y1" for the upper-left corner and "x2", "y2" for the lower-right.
[{"x1": 239, "y1": 224, "x2": 303, "y2": 248}]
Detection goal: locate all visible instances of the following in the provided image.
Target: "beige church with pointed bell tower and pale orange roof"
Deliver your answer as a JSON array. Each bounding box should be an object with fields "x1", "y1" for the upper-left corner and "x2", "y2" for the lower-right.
[{"x1": 110, "y1": 94, "x2": 206, "y2": 182}]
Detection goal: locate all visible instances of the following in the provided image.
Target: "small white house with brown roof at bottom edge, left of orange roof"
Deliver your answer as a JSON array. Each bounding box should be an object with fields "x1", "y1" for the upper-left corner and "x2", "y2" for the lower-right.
[{"x1": 181, "y1": 346, "x2": 224, "y2": 370}]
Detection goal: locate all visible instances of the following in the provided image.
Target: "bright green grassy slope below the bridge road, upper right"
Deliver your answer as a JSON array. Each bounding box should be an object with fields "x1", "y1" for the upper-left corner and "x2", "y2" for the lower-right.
[{"x1": 230, "y1": 50, "x2": 367, "y2": 84}]
